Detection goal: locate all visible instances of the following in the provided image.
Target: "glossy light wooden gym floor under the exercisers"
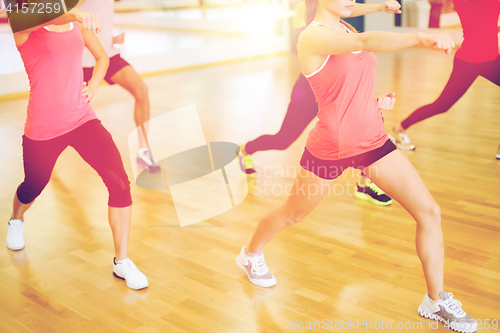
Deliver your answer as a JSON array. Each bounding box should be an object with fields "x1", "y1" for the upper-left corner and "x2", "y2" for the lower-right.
[{"x1": 0, "y1": 48, "x2": 500, "y2": 333}]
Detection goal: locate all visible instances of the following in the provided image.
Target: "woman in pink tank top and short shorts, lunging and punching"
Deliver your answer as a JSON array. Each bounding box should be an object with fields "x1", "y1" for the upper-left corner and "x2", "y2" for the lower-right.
[{"x1": 236, "y1": 0, "x2": 477, "y2": 332}]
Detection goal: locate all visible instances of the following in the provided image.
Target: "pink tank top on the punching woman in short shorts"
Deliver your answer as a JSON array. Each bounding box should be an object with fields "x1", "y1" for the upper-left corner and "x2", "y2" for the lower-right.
[{"x1": 306, "y1": 22, "x2": 388, "y2": 160}]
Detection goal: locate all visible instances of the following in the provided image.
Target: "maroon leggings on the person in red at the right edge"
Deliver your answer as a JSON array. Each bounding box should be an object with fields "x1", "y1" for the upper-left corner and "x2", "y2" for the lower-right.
[{"x1": 401, "y1": 56, "x2": 500, "y2": 129}]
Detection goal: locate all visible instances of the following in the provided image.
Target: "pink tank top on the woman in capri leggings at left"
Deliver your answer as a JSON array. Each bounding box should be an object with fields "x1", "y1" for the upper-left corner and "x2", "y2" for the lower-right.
[{"x1": 18, "y1": 23, "x2": 97, "y2": 140}]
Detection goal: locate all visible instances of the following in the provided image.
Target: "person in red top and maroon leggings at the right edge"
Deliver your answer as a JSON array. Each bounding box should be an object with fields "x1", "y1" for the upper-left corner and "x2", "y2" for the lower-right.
[{"x1": 392, "y1": 0, "x2": 500, "y2": 152}]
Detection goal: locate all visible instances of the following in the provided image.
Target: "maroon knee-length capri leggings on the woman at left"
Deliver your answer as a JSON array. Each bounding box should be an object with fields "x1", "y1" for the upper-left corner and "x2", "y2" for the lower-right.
[{"x1": 17, "y1": 119, "x2": 132, "y2": 207}]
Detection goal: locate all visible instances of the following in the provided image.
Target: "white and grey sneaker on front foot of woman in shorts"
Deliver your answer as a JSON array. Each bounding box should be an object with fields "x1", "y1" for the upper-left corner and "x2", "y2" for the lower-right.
[{"x1": 418, "y1": 291, "x2": 477, "y2": 333}]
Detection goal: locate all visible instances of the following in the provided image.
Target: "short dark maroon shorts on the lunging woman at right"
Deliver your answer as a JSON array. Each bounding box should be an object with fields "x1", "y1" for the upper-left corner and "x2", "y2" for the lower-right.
[{"x1": 300, "y1": 139, "x2": 396, "y2": 179}]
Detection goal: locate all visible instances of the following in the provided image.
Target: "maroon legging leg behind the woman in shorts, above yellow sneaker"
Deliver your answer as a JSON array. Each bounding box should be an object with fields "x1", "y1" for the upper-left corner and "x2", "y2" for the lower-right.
[{"x1": 245, "y1": 74, "x2": 318, "y2": 154}]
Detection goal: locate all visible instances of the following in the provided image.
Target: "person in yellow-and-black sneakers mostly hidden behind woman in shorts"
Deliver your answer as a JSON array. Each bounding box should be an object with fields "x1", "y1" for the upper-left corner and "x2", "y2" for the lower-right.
[{"x1": 240, "y1": 0, "x2": 401, "y2": 206}]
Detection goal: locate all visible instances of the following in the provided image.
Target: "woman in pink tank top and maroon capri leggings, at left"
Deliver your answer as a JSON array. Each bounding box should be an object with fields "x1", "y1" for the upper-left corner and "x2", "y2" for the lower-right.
[{"x1": 7, "y1": 3, "x2": 148, "y2": 289}]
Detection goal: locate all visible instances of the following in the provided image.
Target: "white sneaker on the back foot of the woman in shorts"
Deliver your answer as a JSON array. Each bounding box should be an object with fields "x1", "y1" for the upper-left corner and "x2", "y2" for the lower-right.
[{"x1": 236, "y1": 246, "x2": 276, "y2": 288}]
